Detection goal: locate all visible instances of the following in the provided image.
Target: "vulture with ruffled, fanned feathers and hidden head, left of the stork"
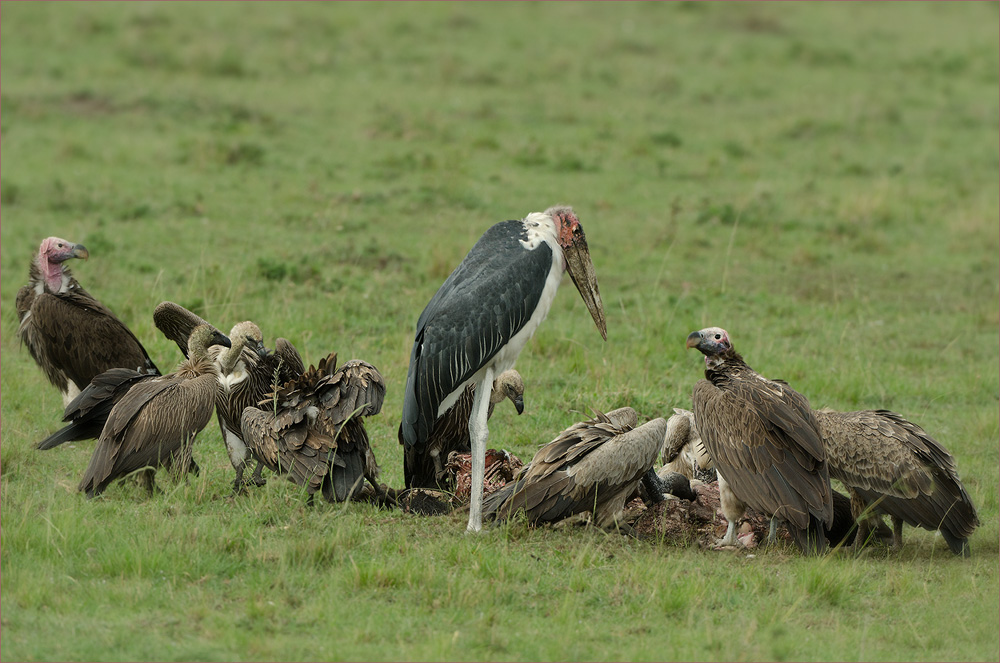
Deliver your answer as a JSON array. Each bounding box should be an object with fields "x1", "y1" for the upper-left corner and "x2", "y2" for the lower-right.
[{"x1": 240, "y1": 353, "x2": 385, "y2": 503}]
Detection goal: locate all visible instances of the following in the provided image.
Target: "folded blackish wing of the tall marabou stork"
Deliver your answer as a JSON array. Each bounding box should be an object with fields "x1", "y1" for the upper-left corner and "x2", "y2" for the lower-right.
[{"x1": 401, "y1": 221, "x2": 552, "y2": 450}]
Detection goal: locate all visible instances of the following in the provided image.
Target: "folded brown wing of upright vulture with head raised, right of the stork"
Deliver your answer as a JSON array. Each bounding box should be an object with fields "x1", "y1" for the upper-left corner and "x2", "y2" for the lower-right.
[{"x1": 693, "y1": 380, "x2": 833, "y2": 530}]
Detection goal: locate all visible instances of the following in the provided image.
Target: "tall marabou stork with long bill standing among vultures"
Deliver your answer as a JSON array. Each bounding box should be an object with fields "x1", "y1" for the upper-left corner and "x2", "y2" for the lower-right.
[{"x1": 400, "y1": 206, "x2": 608, "y2": 532}]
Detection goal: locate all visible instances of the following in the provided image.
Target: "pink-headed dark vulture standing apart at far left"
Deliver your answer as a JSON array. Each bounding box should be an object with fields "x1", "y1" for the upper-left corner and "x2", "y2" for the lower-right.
[{"x1": 16, "y1": 237, "x2": 159, "y2": 408}]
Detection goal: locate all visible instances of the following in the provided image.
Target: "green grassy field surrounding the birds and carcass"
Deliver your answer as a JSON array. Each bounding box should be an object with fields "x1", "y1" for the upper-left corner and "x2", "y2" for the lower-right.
[{"x1": 0, "y1": 2, "x2": 1000, "y2": 661}]
